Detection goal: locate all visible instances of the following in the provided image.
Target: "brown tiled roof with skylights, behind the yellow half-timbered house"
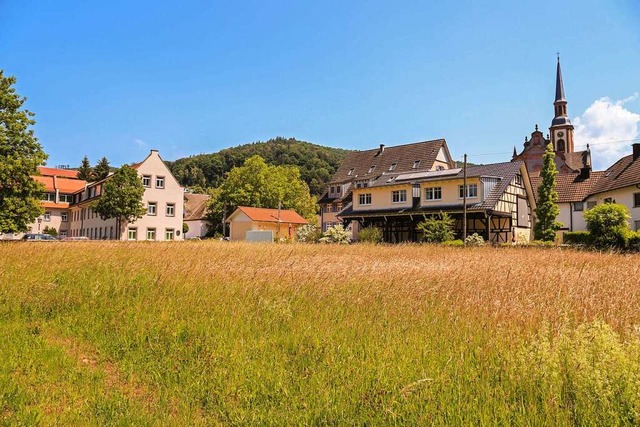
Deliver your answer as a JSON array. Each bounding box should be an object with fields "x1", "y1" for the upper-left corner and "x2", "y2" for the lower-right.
[{"x1": 331, "y1": 139, "x2": 453, "y2": 183}]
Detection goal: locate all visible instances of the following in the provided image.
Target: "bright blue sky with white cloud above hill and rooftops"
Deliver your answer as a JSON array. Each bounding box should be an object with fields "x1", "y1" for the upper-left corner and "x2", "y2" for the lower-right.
[{"x1": 0, "y1": 0, "x2": 640, "y2": 168}]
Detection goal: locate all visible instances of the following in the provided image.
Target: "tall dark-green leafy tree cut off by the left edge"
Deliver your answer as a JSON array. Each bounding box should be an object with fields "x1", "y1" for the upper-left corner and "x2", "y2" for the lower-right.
[{"x1": 0, "y1": 70, "x2": 47, "y2": 233}]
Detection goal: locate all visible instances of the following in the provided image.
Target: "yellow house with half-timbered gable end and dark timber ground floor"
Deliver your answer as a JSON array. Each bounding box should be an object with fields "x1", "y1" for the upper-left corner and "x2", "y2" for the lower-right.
[{"x1": 340, "y1": 161, "x2": 535, "y2": 243}]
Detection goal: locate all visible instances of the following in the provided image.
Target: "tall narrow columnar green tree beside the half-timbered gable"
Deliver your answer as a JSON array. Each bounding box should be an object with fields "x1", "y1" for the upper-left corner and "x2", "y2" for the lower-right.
[{"x1": 533, "y1": 143, "x2": 562, "y2": 242}]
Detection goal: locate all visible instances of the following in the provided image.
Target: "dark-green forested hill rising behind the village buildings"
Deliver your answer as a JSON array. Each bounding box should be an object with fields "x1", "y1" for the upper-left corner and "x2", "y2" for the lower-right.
[{"x1": 167, "y1": 137, "x2": 348, "y2": 195}]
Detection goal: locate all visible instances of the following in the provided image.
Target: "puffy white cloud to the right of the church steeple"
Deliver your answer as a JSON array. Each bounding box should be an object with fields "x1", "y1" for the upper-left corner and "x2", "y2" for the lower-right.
[{"x1": 573, "y1": 93, "x2": 640, "y2": 170}]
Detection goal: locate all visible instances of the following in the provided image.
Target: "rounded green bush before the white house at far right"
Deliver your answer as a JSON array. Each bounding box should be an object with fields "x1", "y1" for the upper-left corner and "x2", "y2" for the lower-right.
[{"x1": 583, "y1": 203, "x2": 630, "y2": 248}]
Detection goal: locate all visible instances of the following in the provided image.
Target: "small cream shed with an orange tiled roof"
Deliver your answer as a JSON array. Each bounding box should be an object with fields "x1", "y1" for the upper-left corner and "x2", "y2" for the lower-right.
[{"x1": 227, "y1": 206, "x2": 309, "y2": 240}]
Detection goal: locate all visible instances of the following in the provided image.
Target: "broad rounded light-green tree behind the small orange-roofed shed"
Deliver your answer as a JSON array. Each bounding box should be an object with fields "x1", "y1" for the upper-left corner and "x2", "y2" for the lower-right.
[{"x1": 208, "y1": 156, "x2": 318, "y2": 232}]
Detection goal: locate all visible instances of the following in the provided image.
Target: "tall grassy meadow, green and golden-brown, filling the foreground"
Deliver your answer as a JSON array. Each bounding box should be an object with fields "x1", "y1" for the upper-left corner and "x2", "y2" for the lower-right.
[{"x1": 0, "y1": 241, "x2": 640, "y2": 425}]
